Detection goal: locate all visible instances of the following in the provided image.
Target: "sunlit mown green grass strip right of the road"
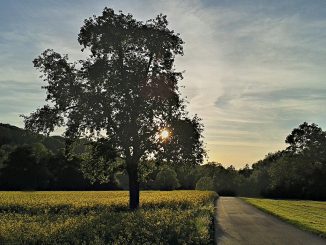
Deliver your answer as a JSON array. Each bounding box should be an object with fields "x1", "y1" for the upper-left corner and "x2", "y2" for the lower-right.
[{"x1": 242, "y1": 198, "x2": 326, "y2": 237}]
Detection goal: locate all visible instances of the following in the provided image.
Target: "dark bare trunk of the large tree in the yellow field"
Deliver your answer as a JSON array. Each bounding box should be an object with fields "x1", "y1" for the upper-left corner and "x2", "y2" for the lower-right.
[{"x1": 127, "y1": 162, "x2": 139, "y2": 210}]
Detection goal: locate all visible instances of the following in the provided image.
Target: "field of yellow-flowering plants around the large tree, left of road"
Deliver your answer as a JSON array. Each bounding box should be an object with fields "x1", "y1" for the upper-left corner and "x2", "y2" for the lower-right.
[{"x1": 0, "y1": 191, "x2": 216, "y2": 244}]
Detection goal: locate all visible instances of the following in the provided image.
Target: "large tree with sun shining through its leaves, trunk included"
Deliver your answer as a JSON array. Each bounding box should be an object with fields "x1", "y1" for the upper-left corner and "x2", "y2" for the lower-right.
[{"x1": 25, "y1": 8, "x2": 205, "y2": 209}]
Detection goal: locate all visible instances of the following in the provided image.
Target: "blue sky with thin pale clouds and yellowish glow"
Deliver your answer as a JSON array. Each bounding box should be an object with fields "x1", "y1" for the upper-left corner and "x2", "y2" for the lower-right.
[{"x1": 0, "y1": 0, "x2": 326, "y2": 168}]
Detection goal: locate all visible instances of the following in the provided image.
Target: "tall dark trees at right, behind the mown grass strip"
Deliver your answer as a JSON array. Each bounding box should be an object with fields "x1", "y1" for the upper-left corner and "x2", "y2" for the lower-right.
[{"x1": 244, "y1": 122, "x2": 326, "y2": 200}]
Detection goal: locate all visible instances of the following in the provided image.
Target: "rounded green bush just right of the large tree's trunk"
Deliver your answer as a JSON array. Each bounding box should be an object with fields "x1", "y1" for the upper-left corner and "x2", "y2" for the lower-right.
[{"x1": 155, "y1": 166, "x2": 180, "y2": 190}]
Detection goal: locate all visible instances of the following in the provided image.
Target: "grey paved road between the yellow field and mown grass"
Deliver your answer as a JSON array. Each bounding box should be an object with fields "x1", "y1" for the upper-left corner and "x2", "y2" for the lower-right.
[{"x1": 215, "y1": 197, "x2": 326, "y2": 245}]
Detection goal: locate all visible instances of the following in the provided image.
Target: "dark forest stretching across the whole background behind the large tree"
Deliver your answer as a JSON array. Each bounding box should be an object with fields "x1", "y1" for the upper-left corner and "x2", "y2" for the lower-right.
[{"x1": 0, "y1": 123, "x2": 326, "y2": 200}]
